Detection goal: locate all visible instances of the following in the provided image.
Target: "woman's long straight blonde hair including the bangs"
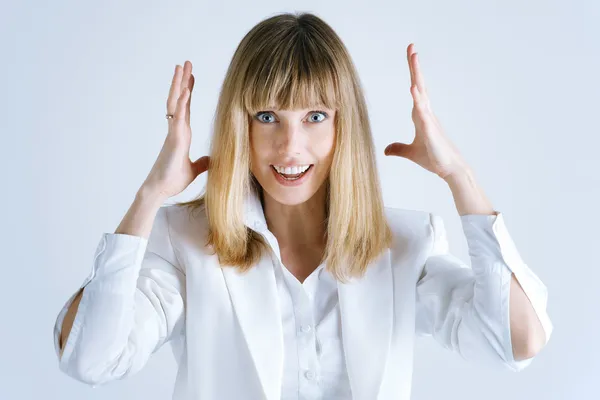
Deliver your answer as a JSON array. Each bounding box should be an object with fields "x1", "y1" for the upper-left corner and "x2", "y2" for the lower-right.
[{"x1": 176, "y1": 13, "x2": 392, "y2": 282}]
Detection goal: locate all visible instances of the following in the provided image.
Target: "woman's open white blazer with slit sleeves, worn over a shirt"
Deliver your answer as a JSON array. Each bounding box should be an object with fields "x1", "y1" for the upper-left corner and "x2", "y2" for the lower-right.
[{"x1": 54, "y1": 189, "x2": 553, "y2": 400}]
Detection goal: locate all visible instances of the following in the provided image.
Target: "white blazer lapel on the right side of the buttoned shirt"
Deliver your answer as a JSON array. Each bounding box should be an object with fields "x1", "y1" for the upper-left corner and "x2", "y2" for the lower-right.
[{"x1": 338, "y1": 251, "x2": 394, "y2": 400}]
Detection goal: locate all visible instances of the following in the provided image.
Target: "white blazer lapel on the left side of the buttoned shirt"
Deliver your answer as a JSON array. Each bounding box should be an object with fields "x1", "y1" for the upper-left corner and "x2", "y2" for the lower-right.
[{"x1": 221, "y1": 254, "x2": 283, "y2": 400}]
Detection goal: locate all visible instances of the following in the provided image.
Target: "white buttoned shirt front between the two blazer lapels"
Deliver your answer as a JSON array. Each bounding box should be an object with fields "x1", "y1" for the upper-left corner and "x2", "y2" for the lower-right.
[{"x1": 274, "y1": 255, "x2": 352, "y2": 400}]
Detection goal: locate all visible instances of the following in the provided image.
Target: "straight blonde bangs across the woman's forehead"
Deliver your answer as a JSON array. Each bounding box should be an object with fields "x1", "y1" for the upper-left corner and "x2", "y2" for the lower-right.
[{"x1": 243, "y1": 34, "x2": 339, "y2": 115}]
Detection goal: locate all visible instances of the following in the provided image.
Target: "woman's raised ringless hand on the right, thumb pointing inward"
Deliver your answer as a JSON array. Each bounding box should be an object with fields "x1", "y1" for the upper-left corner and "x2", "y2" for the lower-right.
[{"x1": 385, "y1": 43, "x2": 468, "y2": 179}]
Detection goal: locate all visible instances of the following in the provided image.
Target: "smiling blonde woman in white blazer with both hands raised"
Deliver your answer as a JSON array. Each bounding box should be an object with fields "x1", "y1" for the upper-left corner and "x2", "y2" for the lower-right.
[{"x1": 54, "y1": 10, "x2": 552, "y2": 400}]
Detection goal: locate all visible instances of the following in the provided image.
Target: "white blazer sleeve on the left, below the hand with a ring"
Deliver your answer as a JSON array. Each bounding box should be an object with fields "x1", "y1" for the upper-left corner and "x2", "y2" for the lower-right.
[{"x1": 54, "y1": 207, "x2": 185, "y2": 387}]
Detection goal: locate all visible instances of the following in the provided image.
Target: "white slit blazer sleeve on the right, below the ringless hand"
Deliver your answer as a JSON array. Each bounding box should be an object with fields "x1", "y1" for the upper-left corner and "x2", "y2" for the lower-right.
[{"x1": 416, "y1": 211, "x2": 553, "y2": 371}]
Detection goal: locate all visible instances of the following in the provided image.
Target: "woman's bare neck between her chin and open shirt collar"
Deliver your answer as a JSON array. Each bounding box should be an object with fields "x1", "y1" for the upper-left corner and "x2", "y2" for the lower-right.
[{"x1": 261, "y1": 183, "x2": 327, "y2": 249}]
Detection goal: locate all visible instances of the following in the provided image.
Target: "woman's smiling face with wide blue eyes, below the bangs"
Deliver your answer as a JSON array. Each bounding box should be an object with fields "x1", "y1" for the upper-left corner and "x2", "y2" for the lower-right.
[{"x1": 250, "y1": 108, "x2": 335, "y2": 205}]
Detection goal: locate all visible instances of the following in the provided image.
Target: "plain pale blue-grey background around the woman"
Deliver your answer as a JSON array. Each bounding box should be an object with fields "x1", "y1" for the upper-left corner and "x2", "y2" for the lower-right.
[{"x1": 0, "y1": 0, "x2": 600, "y2": 400}]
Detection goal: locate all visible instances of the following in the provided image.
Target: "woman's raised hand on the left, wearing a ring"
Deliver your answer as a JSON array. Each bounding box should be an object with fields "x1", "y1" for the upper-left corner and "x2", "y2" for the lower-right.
[{"x1": 142, "y1": 61, "x2": 210, "y2": 198}]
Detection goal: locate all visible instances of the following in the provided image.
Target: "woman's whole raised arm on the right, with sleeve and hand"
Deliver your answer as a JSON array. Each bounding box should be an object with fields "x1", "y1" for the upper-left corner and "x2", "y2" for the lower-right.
[{"x1": 384, "y1": 43, "x2": 552, "y2": 370}]
